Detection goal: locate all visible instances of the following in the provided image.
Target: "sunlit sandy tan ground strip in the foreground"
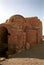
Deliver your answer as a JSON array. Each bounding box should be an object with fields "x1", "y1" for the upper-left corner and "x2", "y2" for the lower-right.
[{"x1": 1, "y1": 58, "x2": 44, "y2": 65}]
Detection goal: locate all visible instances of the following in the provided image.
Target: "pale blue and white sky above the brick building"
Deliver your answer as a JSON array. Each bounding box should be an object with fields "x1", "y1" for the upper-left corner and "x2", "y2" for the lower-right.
[{"x1": 0, "y1": 0, "x2": 44, "y2": 34}]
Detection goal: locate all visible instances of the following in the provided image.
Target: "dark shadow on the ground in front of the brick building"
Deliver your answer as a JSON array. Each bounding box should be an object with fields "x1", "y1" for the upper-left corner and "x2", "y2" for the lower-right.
[{"x1": 9, "y1": 42, "x2": 44, "y2": 59}]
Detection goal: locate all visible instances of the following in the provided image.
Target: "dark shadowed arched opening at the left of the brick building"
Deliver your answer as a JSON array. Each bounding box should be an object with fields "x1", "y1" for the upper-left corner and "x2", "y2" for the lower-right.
[{"x1": 0, "y1": 26, "x2": 9, "y2": 57}]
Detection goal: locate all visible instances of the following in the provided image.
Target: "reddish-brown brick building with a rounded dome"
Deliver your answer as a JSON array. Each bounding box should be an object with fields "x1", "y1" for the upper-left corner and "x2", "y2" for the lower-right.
[{"x1": 0, "y1": 15, "x2": 42, "y2": 53}]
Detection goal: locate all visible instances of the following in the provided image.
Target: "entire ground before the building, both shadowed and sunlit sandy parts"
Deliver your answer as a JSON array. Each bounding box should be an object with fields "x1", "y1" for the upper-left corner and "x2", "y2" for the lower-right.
[{"x1": 0, "y1": 42, "x2": 44, "y2": 65}]
